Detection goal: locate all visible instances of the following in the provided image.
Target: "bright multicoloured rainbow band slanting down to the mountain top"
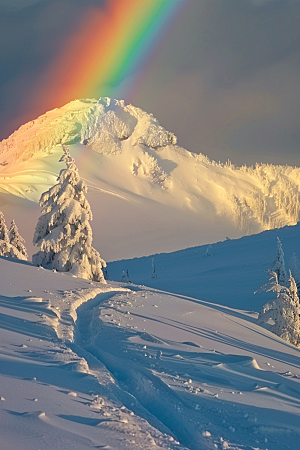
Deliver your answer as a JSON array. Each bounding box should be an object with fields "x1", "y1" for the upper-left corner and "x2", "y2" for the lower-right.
[{"x1": 35, "y1": 0, "x2": 188, "y2": 111}]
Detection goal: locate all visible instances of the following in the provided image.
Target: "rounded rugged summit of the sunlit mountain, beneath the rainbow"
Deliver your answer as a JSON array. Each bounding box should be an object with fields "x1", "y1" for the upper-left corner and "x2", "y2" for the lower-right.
[{"x1": 0, "y1": 97, "x2": 177, "y2": 165}]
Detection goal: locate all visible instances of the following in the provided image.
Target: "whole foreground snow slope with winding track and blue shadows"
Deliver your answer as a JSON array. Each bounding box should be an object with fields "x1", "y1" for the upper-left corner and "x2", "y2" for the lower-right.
[{"x1": 0, "y1": 253, "x2": 300, "y2": 450}]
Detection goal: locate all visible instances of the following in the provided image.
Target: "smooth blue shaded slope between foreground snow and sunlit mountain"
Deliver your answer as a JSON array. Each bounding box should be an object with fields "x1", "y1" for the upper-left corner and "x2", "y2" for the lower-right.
[{"x1": 107, "y1": 223, "x2": 300, "y2": 311}]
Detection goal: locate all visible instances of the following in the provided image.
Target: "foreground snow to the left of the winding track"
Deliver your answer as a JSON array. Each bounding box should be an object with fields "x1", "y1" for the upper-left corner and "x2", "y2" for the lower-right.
[{"x1": 0, "y1": 258, "x2": 188, "y2": 450}]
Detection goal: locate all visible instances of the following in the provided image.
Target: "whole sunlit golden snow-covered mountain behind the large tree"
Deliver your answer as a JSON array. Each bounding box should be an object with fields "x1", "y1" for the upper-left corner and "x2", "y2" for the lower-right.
[{"x1": 0, "y1": 98, "x2": 300, "y2": 261}]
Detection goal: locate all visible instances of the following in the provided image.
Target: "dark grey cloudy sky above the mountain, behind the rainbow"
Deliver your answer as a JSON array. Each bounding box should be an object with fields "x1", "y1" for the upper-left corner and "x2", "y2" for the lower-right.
[{"x1": 0, "y1": 0, "x2": 300, "y2": 166}]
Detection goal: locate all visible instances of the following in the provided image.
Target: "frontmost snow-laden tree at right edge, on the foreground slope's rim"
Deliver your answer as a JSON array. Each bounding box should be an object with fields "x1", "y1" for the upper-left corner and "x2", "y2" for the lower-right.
[{"x1": 258, "y1": 271, "x2": 300, "y2": 347}]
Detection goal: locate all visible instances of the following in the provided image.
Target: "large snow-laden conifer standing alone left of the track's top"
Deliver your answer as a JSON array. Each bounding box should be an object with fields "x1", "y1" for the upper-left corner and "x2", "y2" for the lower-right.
[{"x1": 32, "y1": 145, "x2": 106, "y2": 283}]
